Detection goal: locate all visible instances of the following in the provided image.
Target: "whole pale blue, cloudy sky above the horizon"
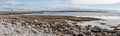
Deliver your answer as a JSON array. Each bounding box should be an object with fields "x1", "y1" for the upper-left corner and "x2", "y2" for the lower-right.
[{"x1": 0, "y1": 0, "x2": 120, "y2": 11}]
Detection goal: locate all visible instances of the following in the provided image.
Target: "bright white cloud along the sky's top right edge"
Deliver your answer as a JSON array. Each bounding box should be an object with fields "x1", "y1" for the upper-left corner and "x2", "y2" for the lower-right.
[{"x1": 71, "y1": 0, "x2": 120, "y2": 4}]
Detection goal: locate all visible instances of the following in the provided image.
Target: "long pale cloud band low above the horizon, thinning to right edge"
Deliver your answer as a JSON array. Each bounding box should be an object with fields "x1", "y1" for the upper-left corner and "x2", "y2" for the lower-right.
[{"x1": 0, "y1": 4, "x2": 120, "y2": 11}]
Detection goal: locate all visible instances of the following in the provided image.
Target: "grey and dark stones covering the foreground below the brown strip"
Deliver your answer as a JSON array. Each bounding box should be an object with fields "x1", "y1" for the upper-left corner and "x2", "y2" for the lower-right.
[{"x1": 0, "y1": 15, "x2": 119, "y2": 36}]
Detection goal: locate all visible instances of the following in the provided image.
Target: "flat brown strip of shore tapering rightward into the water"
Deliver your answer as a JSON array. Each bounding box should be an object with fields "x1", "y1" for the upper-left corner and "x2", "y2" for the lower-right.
[{"x1": 0, "y1": 12, "x2": 100, "y2": 21}]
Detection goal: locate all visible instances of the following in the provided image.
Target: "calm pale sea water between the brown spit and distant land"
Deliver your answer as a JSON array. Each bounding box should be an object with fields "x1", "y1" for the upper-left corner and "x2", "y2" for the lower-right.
[{"x1": 32, "y1": 12, "x2": 120, "y2": 19}]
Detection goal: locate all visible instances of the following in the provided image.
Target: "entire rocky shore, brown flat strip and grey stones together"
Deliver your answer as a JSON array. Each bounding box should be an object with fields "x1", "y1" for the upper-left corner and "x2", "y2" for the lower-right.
[{"x1": 0, "y1": 13, "x2": 120, "y2": 36}]
